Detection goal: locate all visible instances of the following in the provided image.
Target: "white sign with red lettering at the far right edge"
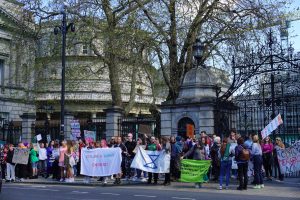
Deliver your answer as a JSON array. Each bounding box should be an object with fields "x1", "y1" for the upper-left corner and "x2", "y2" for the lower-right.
[{"x1": 277, "y1": 140, "x2": 300, "y2": 174}]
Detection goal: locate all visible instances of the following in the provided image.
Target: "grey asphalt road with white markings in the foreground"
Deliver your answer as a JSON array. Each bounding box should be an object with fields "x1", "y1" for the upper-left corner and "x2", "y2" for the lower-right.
[{"x1": 0, "y1": 184, "x2": 300, "y2": 200}]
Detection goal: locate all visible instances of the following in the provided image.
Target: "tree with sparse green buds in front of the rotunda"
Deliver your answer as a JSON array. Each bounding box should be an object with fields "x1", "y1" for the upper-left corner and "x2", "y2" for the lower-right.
[{"x1": 23, "y1": 0, "x2": 155, "y2": 113}]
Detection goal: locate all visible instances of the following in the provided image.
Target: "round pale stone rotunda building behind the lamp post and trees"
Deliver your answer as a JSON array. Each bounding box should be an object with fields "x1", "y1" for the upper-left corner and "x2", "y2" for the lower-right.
[{"x1": 35, "y1": 21, "x2": 162, "y2": 141}]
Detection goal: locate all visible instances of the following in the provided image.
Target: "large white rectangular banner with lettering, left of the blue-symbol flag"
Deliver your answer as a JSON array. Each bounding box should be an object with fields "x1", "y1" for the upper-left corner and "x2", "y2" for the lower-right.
[{"x1": 80, "y1": 148, "x2": 122, "y2": 176}]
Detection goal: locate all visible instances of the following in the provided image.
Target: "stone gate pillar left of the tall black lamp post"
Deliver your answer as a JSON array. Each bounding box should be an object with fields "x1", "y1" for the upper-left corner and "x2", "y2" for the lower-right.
[{"x1": 20, "y1": 113, "x2": 36, "y2": 142}]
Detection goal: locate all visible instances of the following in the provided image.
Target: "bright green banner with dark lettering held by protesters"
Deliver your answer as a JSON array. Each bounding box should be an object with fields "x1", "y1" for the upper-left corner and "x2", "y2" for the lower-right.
[{"x1": 180, "y1": 159, "x2": 211, "y2": 183}]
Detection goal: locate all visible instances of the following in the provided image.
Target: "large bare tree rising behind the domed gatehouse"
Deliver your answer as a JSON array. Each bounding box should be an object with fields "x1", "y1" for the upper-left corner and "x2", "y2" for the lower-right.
[{"x1": 135, "y1": 0, "x2": 285, "y2": 101}]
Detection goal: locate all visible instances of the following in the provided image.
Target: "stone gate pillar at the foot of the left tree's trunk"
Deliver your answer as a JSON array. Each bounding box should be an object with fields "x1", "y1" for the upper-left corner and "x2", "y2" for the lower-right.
[{"x1": 104, "y1": 106, "x2": 124, "y2": 140}]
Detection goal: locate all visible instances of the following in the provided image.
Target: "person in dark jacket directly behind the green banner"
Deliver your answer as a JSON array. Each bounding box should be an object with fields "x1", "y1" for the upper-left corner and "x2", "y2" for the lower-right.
[{"x1": 182, "y1": 138, "x2": 207, "y2": 188}]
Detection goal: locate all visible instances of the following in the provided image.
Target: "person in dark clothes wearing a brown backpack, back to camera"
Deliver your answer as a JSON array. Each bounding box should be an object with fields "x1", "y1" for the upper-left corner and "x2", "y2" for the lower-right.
[{"x1": 235, "y1": 137, "x2": 250, "y2": 190}]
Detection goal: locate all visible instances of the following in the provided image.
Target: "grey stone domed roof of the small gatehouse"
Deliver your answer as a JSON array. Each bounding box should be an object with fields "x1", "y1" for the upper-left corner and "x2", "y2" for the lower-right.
[{"x1": 182, "y1": 67, "x2": 216, "y2": 87}]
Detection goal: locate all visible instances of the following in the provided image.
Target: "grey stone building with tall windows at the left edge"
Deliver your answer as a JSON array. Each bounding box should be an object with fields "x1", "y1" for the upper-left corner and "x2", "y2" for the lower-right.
[{"x1": 0, "y1": 0, "x2": 35, "y2": 142}]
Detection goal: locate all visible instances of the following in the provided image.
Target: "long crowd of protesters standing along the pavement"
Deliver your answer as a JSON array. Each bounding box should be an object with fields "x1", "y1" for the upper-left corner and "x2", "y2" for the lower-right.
[{"x1": 0, "y1": 130, "x2": 285, "y2": 190}]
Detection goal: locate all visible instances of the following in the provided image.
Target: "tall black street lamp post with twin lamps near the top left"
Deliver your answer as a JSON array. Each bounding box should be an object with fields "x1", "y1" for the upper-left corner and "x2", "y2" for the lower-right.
[{"x1": 54, "y1": 4, "x2": 75, "y2": 140}]
